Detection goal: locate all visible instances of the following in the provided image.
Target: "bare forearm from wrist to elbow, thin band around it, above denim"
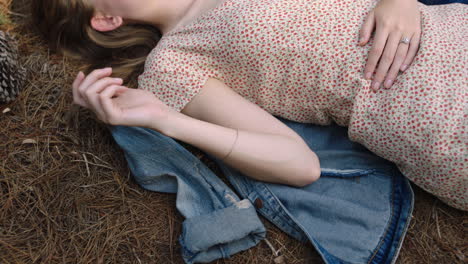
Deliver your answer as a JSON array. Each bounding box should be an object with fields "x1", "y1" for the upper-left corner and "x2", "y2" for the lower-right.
[{"x1": 161, "y1": 114, "x2": 320, "y2": 186}]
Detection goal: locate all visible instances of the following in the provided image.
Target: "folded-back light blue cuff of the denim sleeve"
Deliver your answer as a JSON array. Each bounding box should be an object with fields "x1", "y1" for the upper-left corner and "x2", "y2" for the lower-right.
[{"x1": 179, "y1": 199, "x2": 266, "y2": 263}]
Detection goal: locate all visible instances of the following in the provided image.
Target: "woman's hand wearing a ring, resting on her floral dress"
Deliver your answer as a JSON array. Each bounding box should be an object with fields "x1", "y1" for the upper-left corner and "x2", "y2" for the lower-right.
[{"x1": 359, "y1": 0, "x2": 421, "y2": 90}]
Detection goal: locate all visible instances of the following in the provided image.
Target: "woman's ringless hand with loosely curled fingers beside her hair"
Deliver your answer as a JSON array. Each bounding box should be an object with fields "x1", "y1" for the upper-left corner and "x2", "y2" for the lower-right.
[{"x1": 73, "y1": 68, "x2": 176, "y2": 132}]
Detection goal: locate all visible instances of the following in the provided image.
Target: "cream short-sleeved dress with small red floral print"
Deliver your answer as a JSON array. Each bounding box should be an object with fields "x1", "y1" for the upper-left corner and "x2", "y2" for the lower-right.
[{"x1": 139, "y1": 0, "x2": 468, "y2": 210}]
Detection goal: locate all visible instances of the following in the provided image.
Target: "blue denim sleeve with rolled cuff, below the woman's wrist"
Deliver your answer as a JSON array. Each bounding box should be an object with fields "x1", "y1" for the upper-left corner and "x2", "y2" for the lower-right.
[{"x1": 110, "y1": 126, "x2": 266, "y2": 263}]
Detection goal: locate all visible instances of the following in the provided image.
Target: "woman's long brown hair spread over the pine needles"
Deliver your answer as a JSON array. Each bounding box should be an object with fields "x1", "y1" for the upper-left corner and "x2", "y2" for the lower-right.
[{"x1": 31, "y1": 0, "x2": 161, "y2": 85}]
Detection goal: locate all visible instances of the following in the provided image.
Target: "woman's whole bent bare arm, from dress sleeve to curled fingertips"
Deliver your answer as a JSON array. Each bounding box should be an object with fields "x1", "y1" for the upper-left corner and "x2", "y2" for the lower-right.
[{"x1": 73, "y1": 69, "x2": 320, "y2": 186}]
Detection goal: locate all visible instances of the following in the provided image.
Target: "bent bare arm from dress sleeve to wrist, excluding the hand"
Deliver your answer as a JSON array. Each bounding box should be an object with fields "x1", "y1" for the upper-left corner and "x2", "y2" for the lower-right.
[{"x1": 167, "y1": 79, "x2": 320, "y2": 186}]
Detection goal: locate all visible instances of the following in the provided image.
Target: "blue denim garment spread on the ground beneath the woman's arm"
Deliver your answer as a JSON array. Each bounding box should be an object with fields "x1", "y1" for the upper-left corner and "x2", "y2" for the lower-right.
[{"x1": 111, "y1": 117, "x2": 413, "y2": 263}]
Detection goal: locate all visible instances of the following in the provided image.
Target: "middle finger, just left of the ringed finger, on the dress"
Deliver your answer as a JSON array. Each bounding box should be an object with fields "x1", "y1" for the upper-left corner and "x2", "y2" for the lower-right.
[{"x1": 372, "y1": 34, "x2": 401, "y2": 91}]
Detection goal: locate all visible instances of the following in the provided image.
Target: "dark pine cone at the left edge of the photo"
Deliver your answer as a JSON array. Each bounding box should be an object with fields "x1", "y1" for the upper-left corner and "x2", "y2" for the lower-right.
[{"x1": 0, "y1": 31, "x2": 26, "y2": 103}]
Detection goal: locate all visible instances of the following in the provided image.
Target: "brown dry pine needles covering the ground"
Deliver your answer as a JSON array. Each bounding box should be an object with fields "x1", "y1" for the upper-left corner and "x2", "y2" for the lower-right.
[{"x1": 0, "y1": 0, "x2": 468, "y2": 264}]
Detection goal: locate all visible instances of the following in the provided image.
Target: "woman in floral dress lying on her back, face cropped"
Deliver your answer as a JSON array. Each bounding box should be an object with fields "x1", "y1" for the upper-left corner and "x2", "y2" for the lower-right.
[{"x1": 33, "y1": 0, "x2": 468, "y2": 210}]
